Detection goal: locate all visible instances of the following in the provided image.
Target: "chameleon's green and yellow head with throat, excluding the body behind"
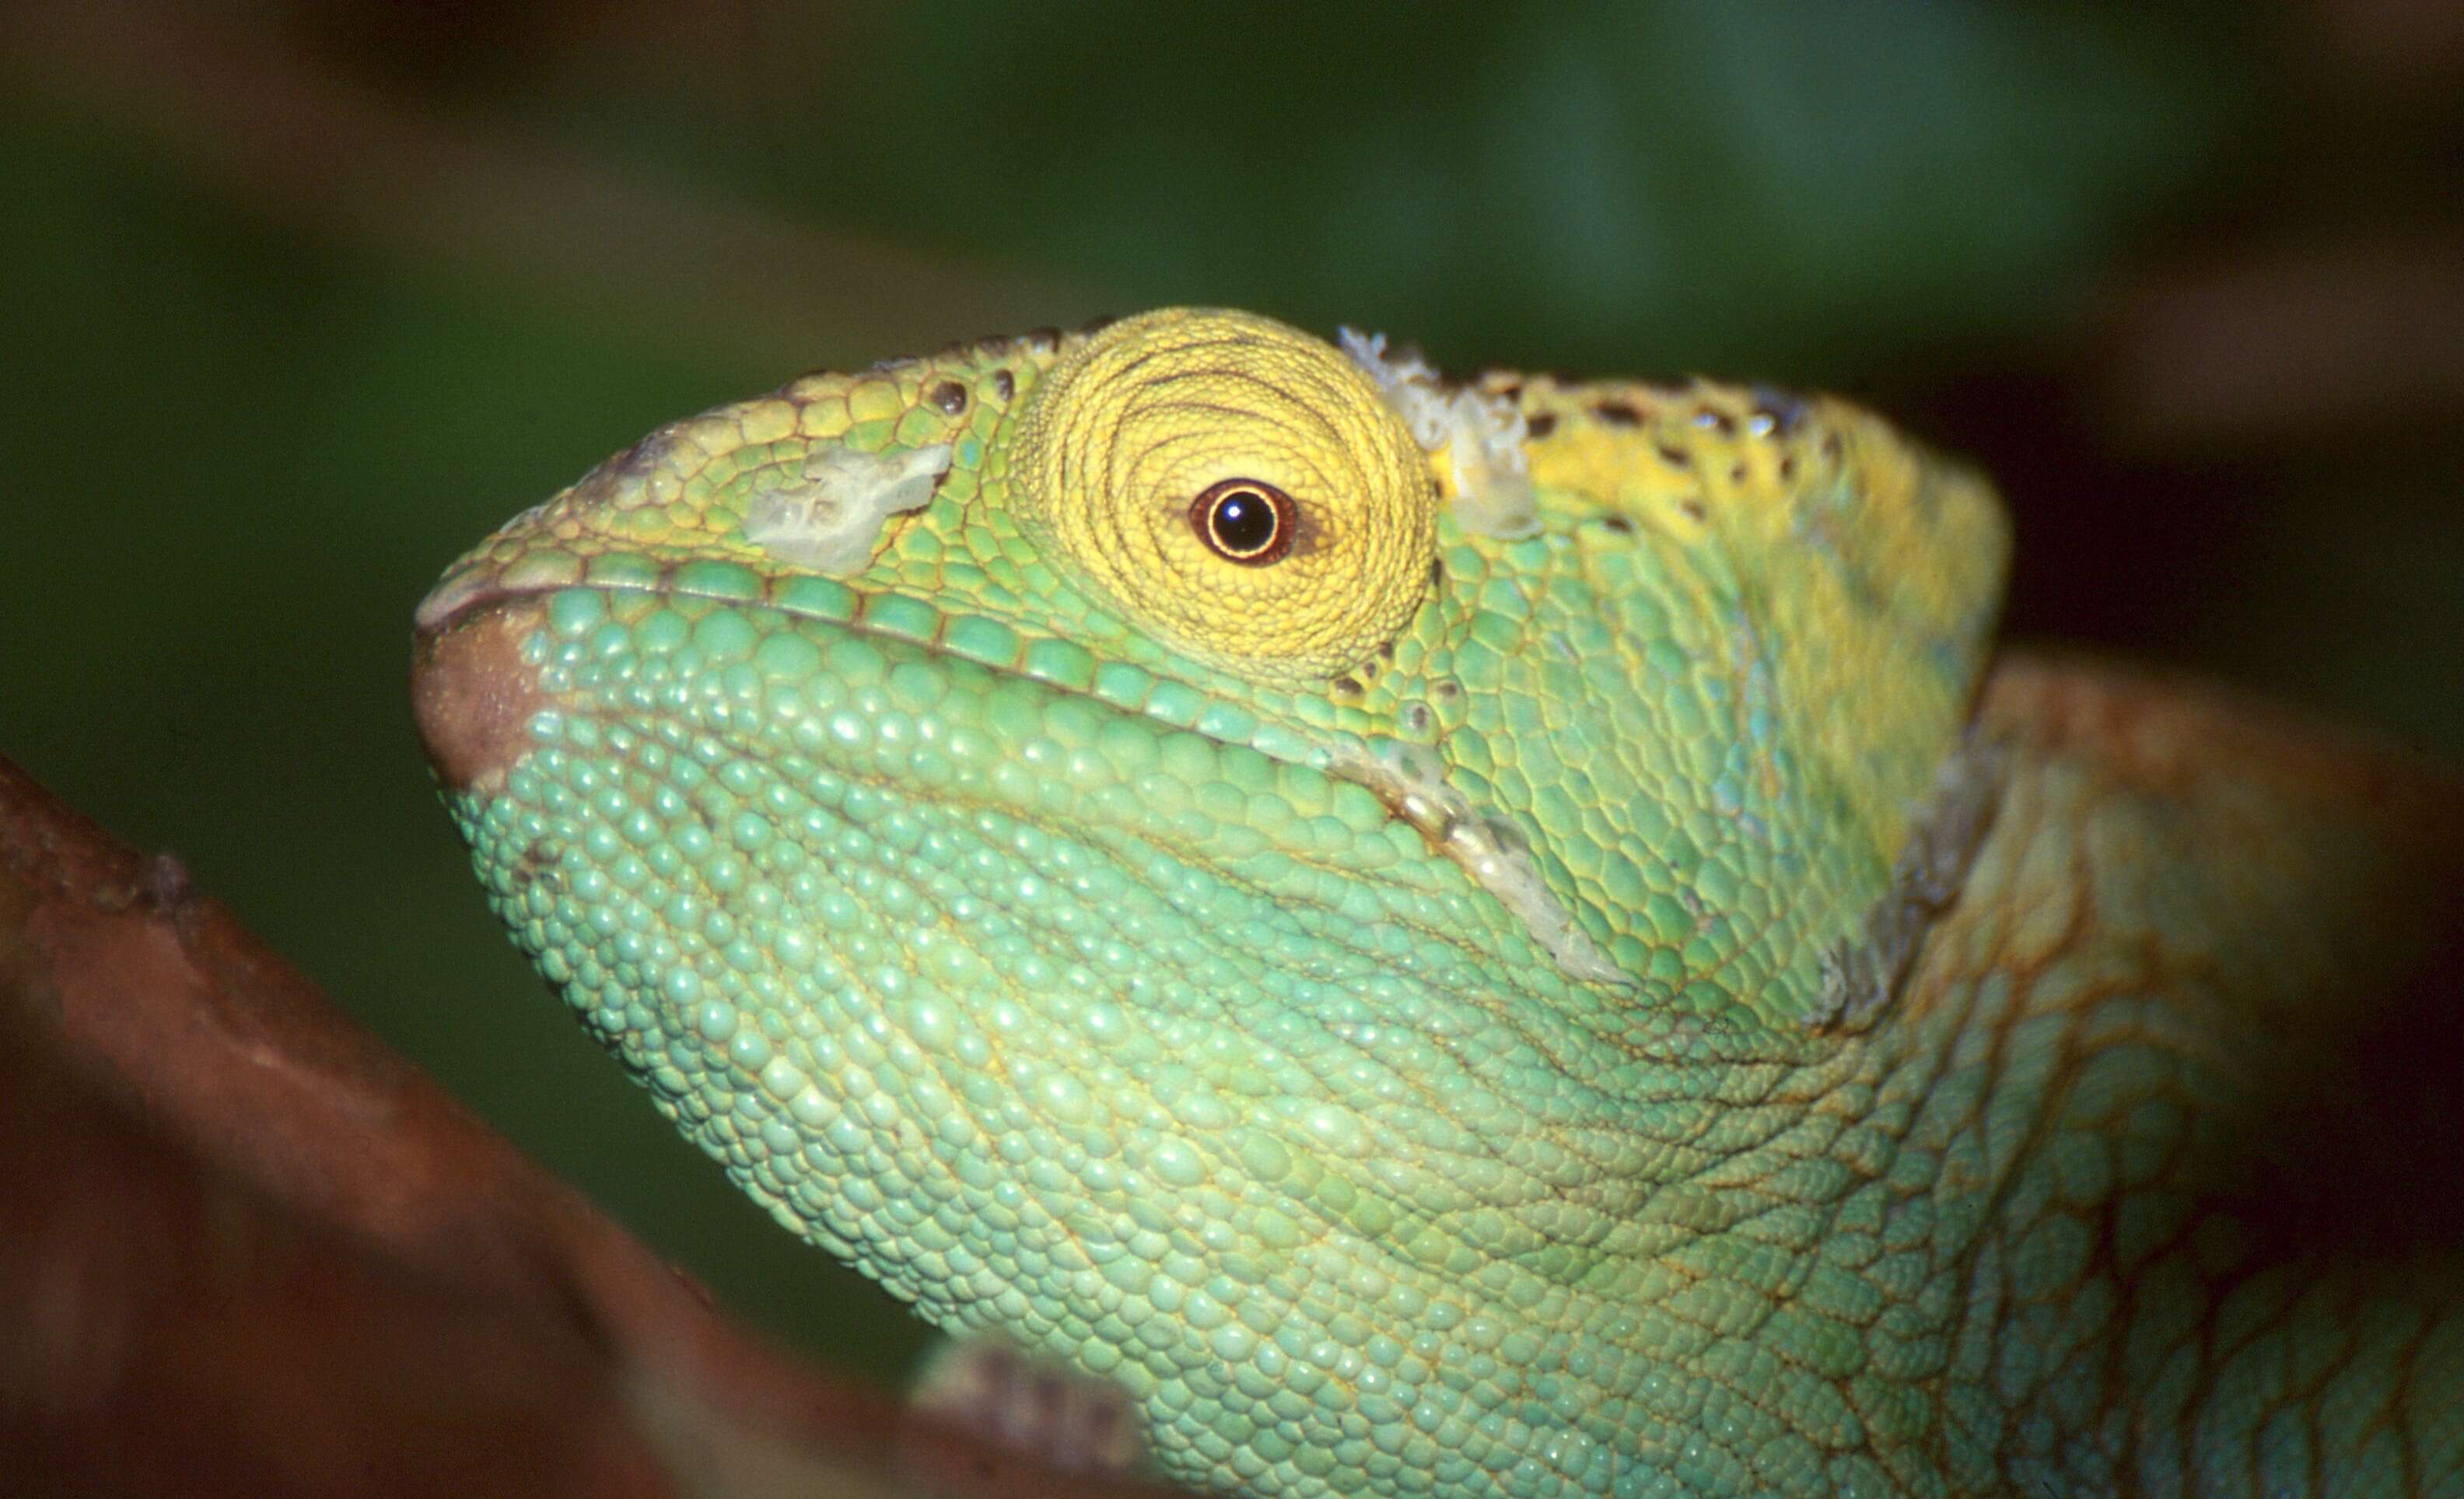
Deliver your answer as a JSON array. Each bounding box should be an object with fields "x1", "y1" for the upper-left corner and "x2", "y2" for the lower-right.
[{"x1": 416, "y1": 310, "x2": 2004, "y2": 1491}]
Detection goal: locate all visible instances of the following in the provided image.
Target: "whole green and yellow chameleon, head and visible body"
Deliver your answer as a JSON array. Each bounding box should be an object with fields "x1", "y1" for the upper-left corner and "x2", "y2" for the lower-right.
[{"x1": 414, "y1": 308, "x2": 2464, "y2": 1499}]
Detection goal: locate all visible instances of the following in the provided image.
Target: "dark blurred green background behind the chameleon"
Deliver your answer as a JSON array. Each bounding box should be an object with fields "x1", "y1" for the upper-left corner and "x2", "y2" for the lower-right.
[{"x1": 0, "y1": 0, "x2": 2464, "y2": 1373}]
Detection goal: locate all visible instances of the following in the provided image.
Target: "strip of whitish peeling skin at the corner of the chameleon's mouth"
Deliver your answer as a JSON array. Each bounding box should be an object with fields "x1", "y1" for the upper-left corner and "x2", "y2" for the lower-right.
[{"x1": 1325, "y1": 740, "x2": 1633, "y2": 989}]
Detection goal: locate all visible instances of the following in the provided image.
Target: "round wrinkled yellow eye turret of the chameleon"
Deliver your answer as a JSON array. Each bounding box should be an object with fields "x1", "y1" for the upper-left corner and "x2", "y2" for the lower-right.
[{"x1": 1010, "y1": 308, "x2": 1437, "y2": 681}]
